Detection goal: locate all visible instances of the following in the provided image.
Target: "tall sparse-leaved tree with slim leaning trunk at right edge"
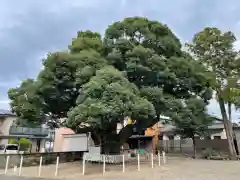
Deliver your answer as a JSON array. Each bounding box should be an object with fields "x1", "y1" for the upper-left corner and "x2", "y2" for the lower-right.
[{"x1": 189, "y1": 28, "x2": 239, "y2": 157}]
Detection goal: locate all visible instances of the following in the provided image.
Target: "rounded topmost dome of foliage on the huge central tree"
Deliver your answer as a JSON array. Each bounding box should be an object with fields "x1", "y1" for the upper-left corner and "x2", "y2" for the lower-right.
[{"x1": 105, "y1": 17, "x2": 182, "y2": 58}]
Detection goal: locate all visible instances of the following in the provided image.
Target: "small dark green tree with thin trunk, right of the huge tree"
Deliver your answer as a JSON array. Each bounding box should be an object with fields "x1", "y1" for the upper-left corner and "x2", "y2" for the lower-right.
[{"x1": 171, "y1": 98, "x2": 214, "y2": 158}]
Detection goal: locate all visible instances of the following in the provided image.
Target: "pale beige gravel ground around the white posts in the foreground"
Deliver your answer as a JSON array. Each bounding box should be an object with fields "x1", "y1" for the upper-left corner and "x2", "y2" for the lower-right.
[{"x1": 0, "y1": 158, "x2": 240, "y2": 180}]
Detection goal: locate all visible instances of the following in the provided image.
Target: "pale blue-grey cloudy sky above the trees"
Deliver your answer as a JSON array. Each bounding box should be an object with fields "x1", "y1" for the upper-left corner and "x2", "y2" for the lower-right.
[{"x1": 0, "y1": 0, "x2": 240, "y2": 119}]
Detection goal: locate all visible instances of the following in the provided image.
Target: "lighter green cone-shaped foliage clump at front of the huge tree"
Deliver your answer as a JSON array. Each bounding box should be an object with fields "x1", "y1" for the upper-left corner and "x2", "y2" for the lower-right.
[{"x1": 68, "y1": 66, "x2": 155, "y2": 130}]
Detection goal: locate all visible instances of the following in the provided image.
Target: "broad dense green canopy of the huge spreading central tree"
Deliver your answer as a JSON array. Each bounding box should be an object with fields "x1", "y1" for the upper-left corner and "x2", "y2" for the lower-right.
[{"x1": 9, "y1": 17, "x2": 214, "y2": 153}]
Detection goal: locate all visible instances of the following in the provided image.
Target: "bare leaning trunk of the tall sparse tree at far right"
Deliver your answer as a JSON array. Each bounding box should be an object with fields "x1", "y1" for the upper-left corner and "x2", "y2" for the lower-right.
[{"x1": 218, "y1": 94, "x2": 237, "y2": 159}]
